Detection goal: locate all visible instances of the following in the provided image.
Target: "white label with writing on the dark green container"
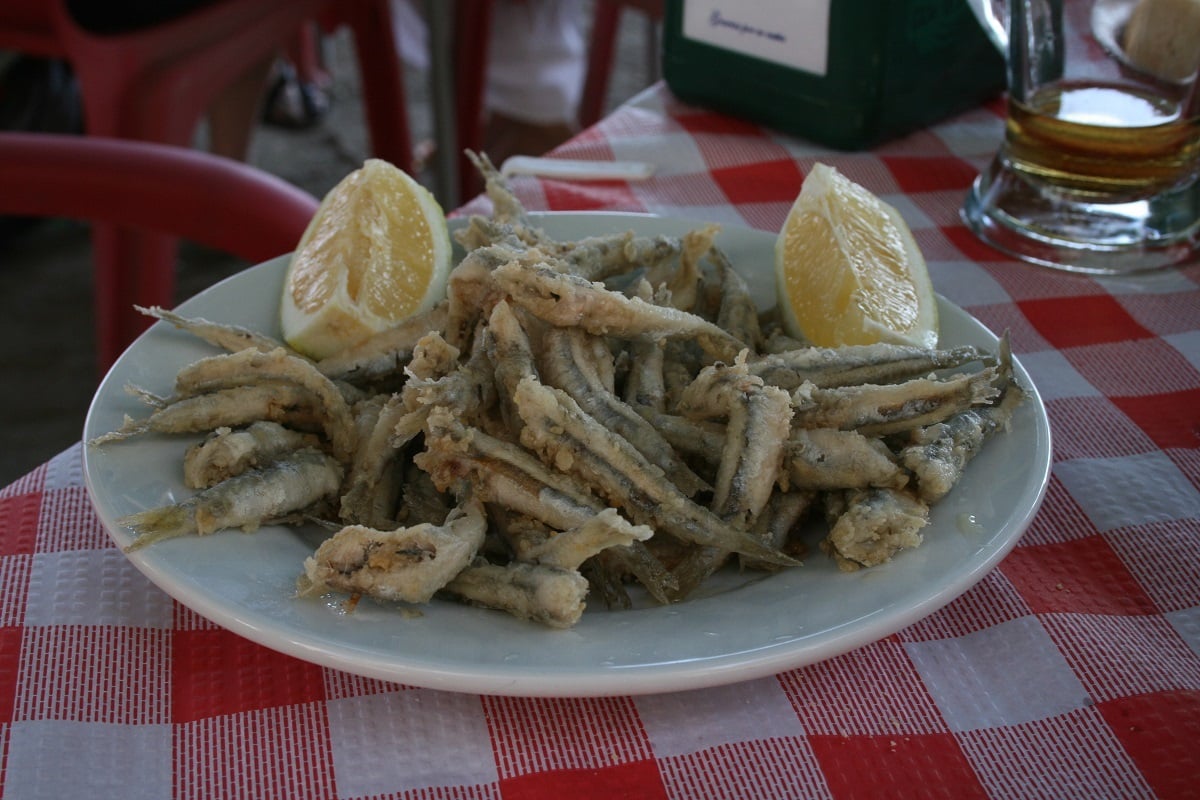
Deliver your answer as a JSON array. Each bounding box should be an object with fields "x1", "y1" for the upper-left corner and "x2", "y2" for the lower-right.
[{"x1": 683, "y1": 0, "x2": 830, "y2": 76}]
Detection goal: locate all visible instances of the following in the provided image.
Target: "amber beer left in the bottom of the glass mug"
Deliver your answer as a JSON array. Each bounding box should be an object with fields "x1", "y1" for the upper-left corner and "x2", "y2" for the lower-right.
[{"x1": 1006, "y1": 82, "x2": 1200, "y2": 201}]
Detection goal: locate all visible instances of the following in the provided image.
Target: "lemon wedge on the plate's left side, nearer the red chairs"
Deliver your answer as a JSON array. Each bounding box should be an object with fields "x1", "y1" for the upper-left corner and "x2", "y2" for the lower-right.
[{"x1": 280, "y1": 158, "x2": 451, "y2": 359}]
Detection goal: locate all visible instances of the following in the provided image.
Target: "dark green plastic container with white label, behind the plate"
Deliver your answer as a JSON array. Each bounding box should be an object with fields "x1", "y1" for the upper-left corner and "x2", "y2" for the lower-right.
[{"x1": 662, "y1": 0, "x2": 1004, "y2": 150}]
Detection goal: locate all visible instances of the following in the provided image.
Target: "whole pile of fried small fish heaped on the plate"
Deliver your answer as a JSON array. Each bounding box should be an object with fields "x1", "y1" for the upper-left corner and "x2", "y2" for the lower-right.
[{"x1": 91, "y1": 156, "x2": 1024, "y2": 627}]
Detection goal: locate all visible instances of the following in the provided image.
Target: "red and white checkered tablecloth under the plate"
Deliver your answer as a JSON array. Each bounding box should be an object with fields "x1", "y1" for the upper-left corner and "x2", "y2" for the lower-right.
[{"x1": 0, "y1": 86, "x2": 1200, "y2": 800}]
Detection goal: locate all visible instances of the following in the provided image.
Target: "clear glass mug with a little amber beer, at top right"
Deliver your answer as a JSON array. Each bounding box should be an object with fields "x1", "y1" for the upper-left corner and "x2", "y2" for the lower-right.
[{"x1": 962, "y1": 0, "x2": 1200, "y2": 275}]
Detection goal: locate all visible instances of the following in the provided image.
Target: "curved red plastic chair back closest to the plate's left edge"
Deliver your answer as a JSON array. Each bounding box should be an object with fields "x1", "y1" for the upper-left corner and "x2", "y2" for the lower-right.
[{"x1": 0, "y1": 133, "x2": 318, "y2": 371}]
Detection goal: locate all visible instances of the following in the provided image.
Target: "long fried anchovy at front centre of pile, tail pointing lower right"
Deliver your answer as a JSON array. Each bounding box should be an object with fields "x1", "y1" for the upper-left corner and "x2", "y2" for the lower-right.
[{"x1": 516, "y1": 378, "x2": 794, "y2": 564}]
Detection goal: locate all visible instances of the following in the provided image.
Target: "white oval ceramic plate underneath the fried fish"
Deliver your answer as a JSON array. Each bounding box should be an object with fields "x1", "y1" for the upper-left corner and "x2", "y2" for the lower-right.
[{"x1": 84, "y1": 213, "x2": 1050, "y2": 696}]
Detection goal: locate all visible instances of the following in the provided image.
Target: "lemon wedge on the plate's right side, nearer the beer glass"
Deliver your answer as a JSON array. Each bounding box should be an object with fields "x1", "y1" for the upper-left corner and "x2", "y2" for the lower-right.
[{"x1": 775, "y1": 164, "x2": 937, "y2": 348}]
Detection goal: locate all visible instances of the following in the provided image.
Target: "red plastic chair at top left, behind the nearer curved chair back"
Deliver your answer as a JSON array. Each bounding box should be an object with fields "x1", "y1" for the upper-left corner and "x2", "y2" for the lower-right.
[{"x1": 0, "y1": 0, "x2": 323, "y2": 363}]
